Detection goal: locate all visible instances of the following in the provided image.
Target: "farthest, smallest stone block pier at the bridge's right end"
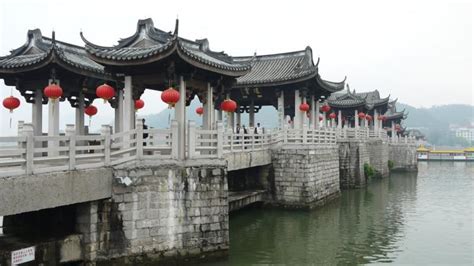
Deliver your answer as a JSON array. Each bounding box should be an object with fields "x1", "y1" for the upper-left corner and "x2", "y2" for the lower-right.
[{"x1": 389, "y1": 143, "x2": 418, "y2": 171}]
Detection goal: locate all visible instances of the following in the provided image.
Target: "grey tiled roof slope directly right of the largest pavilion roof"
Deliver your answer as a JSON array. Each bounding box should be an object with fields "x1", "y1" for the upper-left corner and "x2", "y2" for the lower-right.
[{"x1": 234, "y1": 47, "x2": 318, "y2": 87}]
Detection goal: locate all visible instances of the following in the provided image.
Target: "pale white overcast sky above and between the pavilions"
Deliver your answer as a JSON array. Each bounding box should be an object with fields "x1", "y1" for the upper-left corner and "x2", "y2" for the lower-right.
[{"x1": 0, "y1": 0, "x2": 473, "y2": 135}]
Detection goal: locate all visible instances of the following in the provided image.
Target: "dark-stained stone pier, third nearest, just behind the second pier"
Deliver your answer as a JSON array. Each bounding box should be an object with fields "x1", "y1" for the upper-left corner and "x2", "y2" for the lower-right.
[{"x1": 337, "y1": 140, "x2": 370, "y2": 189}]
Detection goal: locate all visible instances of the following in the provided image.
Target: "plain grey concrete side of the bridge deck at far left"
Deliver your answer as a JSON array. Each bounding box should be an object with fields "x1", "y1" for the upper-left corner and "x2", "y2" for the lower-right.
[{"x1": 0, "y1": 168, "x2": 112, "y2": 216}]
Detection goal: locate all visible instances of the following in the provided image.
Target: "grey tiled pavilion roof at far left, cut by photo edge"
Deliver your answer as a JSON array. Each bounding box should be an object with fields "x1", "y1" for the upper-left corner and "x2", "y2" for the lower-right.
[{"x1": 0, "y1": 29, "x2": 105, "y2": 75}]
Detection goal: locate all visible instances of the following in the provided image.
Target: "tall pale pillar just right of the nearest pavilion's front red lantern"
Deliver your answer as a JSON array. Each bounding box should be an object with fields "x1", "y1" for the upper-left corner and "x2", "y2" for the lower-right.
[{"x1": 175, "y1": 76, "x2": 186, "y2": 159}]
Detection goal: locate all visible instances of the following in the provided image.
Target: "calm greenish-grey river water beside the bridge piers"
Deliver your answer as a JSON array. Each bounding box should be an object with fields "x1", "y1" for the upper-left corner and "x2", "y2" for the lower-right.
[{"x1": 218, "y1": 162, "x2": 474, "y2": 265}]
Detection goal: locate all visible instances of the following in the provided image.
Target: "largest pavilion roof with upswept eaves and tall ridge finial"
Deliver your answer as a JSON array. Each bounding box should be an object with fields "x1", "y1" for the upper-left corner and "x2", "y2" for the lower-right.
[{"x1": 81, "y1": 18, "x2": 250, "y2": 77}]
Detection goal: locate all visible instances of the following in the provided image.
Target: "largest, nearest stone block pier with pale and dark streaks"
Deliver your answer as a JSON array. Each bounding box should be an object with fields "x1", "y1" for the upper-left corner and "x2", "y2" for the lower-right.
[{"x1": 83, "y1": 161, "x2": 229, "y2": 264}]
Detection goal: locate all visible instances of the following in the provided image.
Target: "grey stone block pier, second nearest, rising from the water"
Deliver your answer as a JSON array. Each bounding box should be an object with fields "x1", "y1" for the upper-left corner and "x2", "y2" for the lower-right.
[{"x1": 271, "y1": 145, "x2": 340, "y2": 208}]
